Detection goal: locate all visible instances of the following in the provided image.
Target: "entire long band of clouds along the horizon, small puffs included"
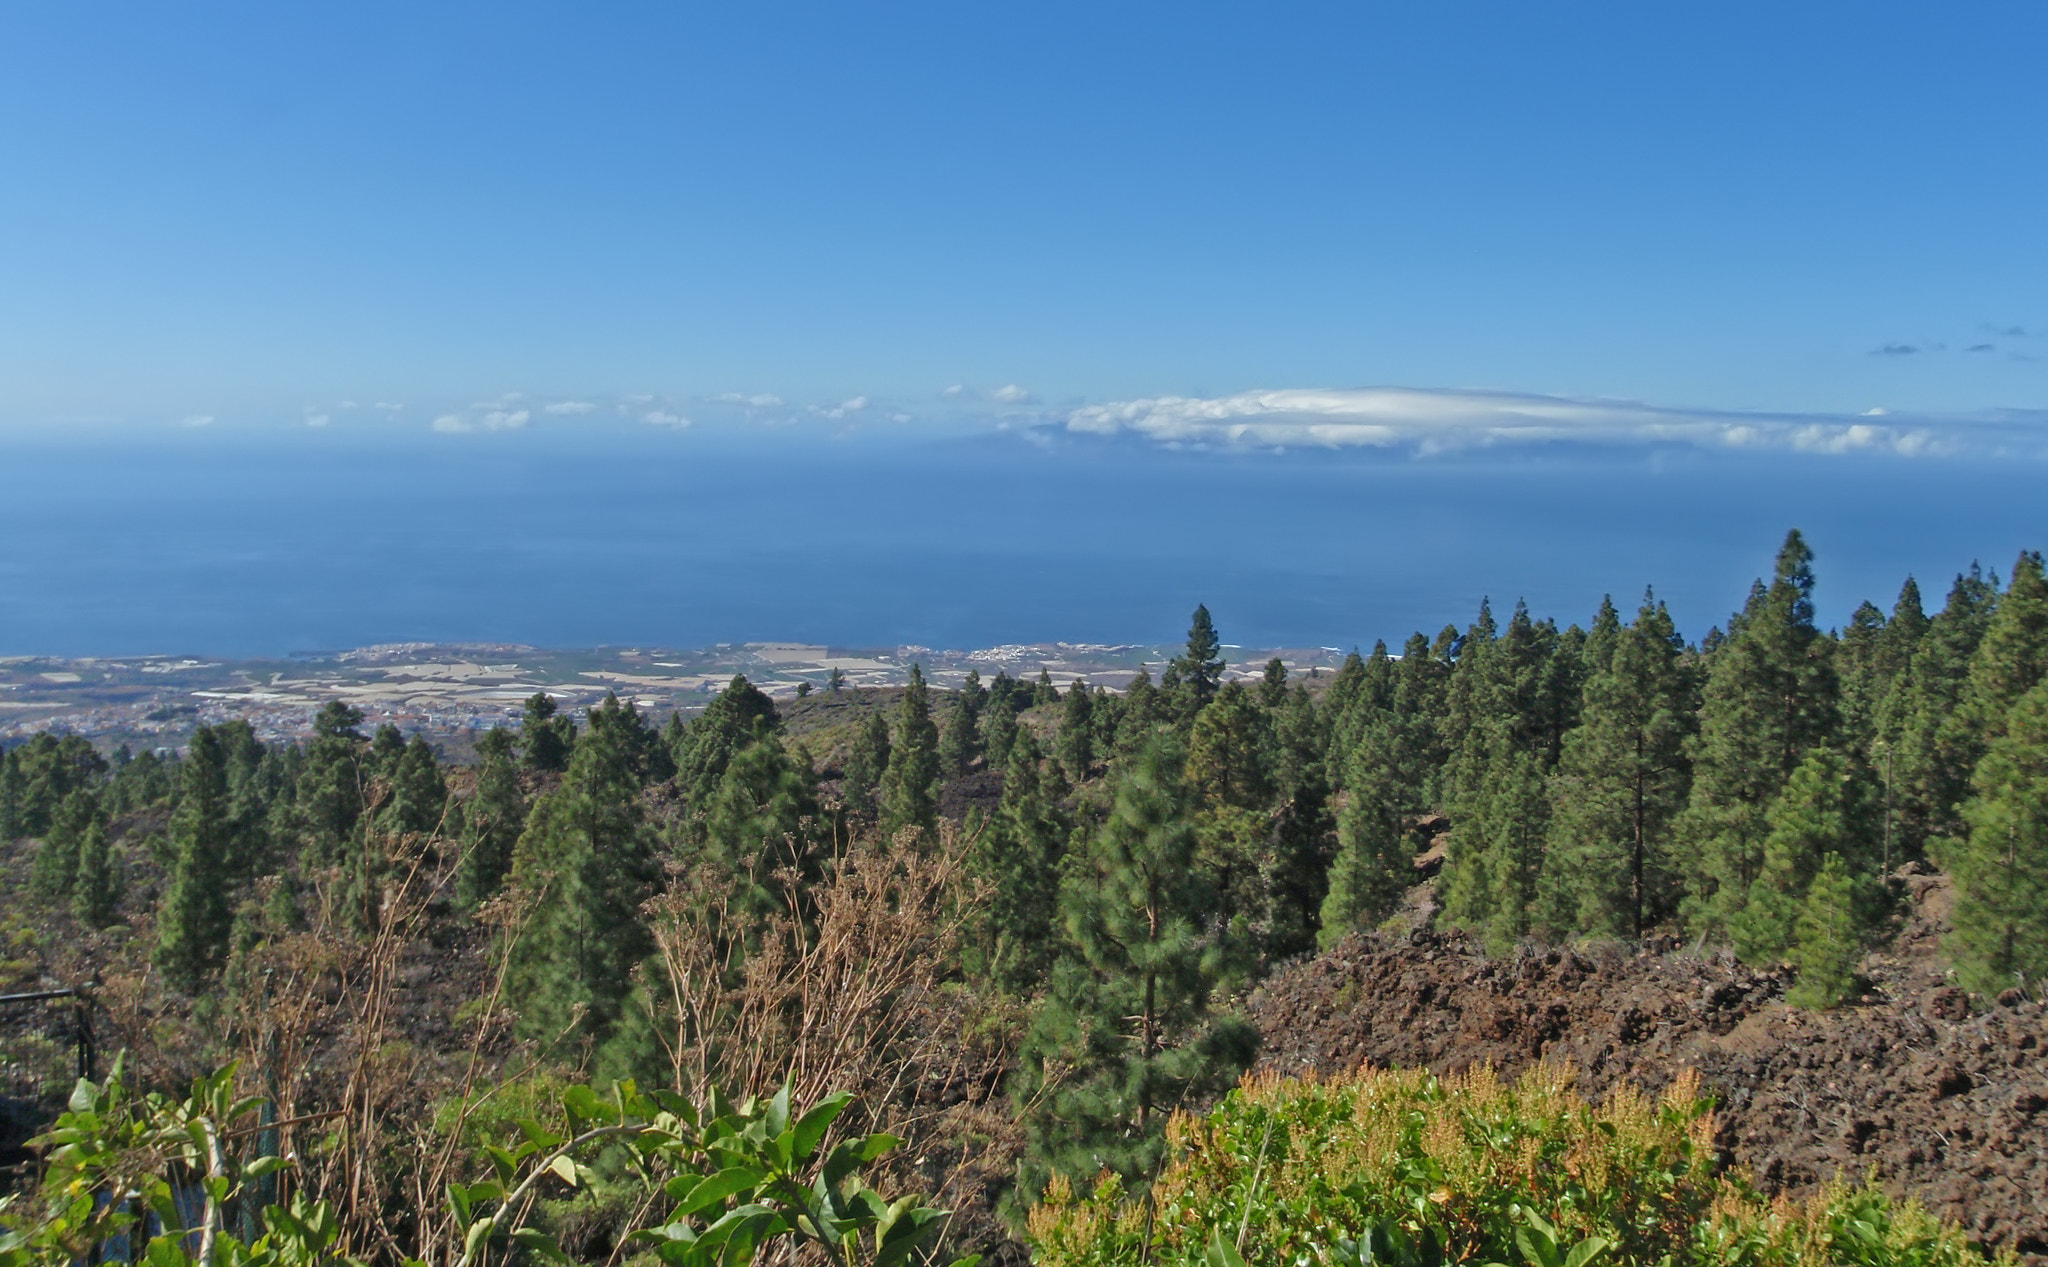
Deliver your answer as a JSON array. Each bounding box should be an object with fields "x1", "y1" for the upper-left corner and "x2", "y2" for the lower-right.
[{"x1": 19, "y1": 383, "x2": 2048, "y2": 461}]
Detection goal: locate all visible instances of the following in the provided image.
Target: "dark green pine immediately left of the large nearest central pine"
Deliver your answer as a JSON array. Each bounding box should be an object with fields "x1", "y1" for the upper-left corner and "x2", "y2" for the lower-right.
[{"x1": 975, "y1": 735, "x2": 1069, "y2": 995}]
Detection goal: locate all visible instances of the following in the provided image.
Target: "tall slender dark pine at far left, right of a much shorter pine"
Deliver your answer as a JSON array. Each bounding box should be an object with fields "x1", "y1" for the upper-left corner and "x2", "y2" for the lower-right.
[{"x1": 156, "y1": 727, "x2": 233, "y2": 995}]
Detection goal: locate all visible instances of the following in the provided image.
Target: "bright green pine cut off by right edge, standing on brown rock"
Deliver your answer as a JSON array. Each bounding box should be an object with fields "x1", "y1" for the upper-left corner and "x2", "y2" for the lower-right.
[{"x1": 1942, "y1": 684, "x2": 2048, "y2": 997}]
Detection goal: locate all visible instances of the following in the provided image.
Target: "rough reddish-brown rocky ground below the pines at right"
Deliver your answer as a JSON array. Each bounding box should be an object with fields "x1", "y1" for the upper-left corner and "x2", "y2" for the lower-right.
[{"x1": 1249, "y1": 872, "x2": 2048, "y2": 1265}]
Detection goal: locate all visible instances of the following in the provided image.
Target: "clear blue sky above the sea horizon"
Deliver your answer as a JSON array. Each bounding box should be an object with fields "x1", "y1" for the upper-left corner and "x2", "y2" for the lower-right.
[{"x1": 0, "y1": 2, "x2": 2048, "y2": 452}]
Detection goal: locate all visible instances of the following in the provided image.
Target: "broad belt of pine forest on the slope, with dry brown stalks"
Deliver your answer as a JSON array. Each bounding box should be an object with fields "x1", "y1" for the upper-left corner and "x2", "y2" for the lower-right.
[{"x1": 0, "y1": 532, "x2": 2048, "y2": 1267}]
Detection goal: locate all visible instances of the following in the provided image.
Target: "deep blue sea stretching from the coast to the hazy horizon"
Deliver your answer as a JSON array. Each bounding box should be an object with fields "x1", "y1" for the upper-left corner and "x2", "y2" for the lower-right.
[{"x1": 0, "y1": 428, "x2": 2048, "y2": 657}]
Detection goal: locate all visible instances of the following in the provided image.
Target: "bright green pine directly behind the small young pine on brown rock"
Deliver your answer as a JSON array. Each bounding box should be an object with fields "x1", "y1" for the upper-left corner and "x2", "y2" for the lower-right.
[{"x1": 1729, "y1": 747, "x2": 1880, "y2": 962}]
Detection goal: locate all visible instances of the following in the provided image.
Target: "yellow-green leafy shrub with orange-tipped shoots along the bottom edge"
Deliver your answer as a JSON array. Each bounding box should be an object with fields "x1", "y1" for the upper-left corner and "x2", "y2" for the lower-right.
[{"x1": 1030, "y1": 1066, "x2": 1982, "y2": 1267}]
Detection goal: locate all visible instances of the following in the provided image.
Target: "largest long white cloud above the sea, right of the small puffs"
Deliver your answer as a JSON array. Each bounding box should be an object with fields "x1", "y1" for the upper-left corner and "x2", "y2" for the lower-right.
[{"x1": 1067, "y1": 387, "x2": 1974, "y2": 466}]
